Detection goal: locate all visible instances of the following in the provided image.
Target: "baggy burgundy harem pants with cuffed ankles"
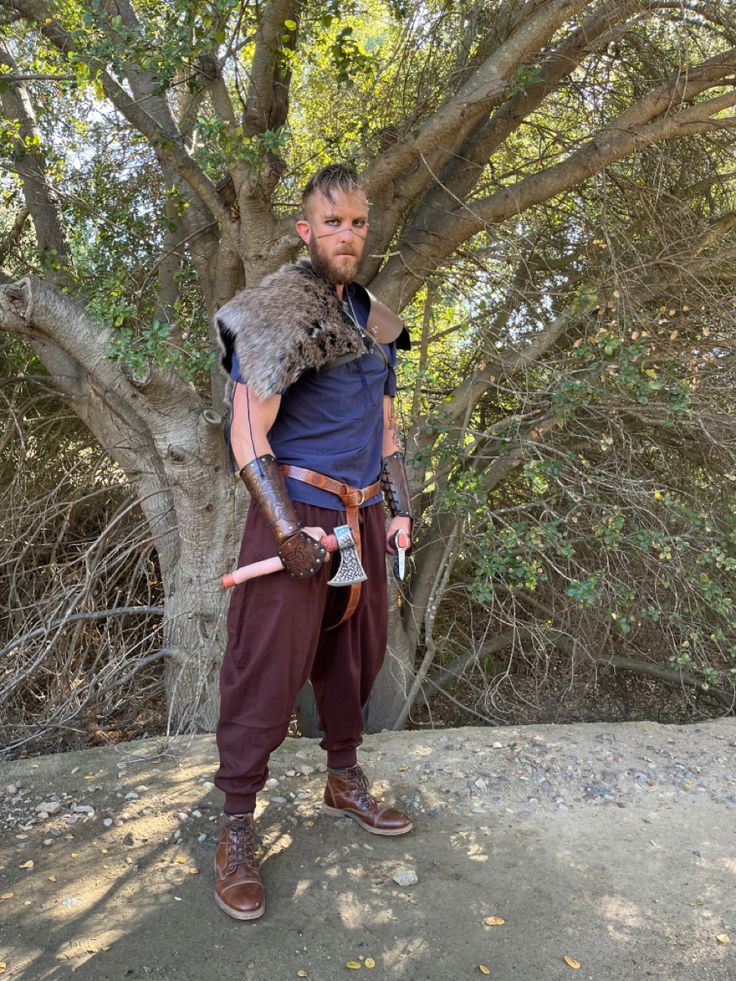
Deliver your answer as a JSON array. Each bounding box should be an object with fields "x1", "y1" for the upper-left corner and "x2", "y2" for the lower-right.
[{"x1": 215, "y1": 502, "x2": 388, "y2": 814}]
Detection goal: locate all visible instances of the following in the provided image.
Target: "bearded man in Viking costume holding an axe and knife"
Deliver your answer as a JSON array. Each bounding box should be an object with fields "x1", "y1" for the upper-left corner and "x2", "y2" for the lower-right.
[{"x1": 215, "y1": 164, "x2": 412, "y2": 920}]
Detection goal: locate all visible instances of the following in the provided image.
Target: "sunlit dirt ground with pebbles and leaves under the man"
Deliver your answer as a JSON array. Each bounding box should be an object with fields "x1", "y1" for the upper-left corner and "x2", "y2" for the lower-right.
[{"x1": 0, "y1": 719, "x2": 736, "y2": 981}]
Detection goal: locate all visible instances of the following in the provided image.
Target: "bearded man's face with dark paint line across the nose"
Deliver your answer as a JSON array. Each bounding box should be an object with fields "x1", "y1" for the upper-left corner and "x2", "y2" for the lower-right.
[{"x1": 296, "y1": 191, "x2": 368, "y2": 285}]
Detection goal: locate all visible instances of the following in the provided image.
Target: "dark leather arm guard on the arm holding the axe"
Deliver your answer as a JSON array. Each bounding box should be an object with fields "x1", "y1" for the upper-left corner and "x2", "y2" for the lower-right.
[{"x1": 240, "y1": 453, "x2": 327, "y2": 579}]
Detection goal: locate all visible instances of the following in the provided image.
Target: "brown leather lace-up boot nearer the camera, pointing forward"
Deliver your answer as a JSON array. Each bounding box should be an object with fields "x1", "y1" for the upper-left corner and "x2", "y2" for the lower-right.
[{"x1": 215, "y1": 814, "x2": 266, "y2": 920}]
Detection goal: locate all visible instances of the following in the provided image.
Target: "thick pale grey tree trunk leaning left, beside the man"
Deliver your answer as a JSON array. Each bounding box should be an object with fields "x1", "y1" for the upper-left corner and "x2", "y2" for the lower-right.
[{"x1": 0, "y1": 277, "x2": 246, "y2": 730}]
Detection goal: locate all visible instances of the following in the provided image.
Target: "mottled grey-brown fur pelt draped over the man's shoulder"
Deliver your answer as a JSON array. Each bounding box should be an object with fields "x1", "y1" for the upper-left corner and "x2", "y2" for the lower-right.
[{"x1": 215, "y1": 262, "x2": 370, "y2": 399}]
